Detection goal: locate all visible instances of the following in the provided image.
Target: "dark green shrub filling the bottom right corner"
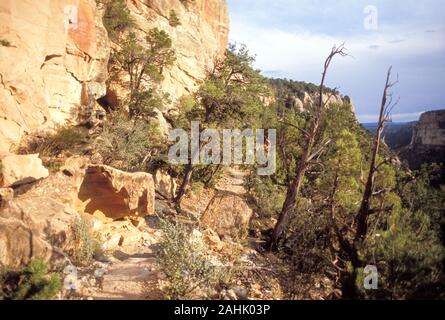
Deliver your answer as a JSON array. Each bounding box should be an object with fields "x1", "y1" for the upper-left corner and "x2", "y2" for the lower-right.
[{"x1": 357, "y1": 210, "x2": 445, "y2": 299}]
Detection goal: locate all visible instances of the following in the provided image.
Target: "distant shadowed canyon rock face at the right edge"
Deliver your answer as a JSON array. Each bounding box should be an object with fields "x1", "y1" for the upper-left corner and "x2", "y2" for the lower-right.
[{"x1": 412, "y1": 110, "x2": 445, "y2": 147}]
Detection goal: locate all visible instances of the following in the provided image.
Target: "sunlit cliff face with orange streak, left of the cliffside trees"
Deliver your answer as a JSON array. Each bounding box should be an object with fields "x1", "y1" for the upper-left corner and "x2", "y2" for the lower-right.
[{"x1": 0, "y1": 0, "x2": 110, "y2": 152}]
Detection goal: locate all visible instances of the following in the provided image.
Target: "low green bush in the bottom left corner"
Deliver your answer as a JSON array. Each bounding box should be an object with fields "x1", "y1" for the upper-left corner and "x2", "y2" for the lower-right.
[{"x1": 0, "y1": 259, "x2": 62, "y2": 300}]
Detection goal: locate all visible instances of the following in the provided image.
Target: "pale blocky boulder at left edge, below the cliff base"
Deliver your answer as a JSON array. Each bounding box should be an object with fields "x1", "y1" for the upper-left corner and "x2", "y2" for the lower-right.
[{"x1": 0, "y1": 154, "x2": 49, "y2": 187}]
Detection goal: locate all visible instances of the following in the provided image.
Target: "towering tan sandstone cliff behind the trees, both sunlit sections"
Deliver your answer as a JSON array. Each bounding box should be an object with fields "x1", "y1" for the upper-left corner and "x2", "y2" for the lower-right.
[{"x1": 0, "y1": 0, "x2": 229, "y2": 153}]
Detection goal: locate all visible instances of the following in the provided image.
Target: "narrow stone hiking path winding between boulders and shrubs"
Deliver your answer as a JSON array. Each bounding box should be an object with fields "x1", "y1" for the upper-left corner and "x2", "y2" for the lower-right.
[{"x1": 76, "y1": 167, "x2": 270, "y2": 300}]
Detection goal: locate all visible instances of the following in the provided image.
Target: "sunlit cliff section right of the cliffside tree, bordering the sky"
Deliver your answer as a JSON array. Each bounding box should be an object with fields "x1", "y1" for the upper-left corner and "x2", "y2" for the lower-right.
[{"x1": 128, "y1": 0, "x2": 229, "y2": 111}]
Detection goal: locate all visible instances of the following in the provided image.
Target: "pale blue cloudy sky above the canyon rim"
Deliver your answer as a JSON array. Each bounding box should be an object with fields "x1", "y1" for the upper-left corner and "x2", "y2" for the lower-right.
[{"x1": 228, "y1": 0, "x2": 445, "y2": 122}]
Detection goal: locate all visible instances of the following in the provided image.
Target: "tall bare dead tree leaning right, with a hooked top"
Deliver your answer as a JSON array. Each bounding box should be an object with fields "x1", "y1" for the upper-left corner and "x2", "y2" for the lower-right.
[{"x1": 271, "y1": 45, "x2": 347, "y2": 247}]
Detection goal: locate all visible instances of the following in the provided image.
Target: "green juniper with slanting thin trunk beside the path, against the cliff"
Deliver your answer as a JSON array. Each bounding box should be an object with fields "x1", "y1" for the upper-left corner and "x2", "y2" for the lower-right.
[{"x1": 175, "y1": 45, "x2": 267, "y2": 208}]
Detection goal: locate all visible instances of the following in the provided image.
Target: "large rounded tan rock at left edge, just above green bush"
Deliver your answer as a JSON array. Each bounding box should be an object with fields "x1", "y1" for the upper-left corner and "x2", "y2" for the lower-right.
[{"x1": 0, "y1": 196, "x2": 75, "y2": 268}]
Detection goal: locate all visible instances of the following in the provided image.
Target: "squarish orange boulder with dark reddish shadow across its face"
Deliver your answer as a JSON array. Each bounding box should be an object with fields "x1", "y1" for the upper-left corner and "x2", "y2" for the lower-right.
[{"x1": 78, "y1": 165, "x2": 155, "y2": 219}]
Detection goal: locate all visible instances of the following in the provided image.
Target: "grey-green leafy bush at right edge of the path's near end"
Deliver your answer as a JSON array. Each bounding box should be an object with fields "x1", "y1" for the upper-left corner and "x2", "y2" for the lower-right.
[{"x1": 158, "y1": 220, "x2": 218, "y2": 299}]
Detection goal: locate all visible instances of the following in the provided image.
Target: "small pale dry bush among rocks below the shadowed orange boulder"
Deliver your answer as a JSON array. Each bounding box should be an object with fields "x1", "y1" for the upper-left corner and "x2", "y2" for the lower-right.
[{"x1": 72, "y1": 218, "x2": 103, "y2": 264}]
